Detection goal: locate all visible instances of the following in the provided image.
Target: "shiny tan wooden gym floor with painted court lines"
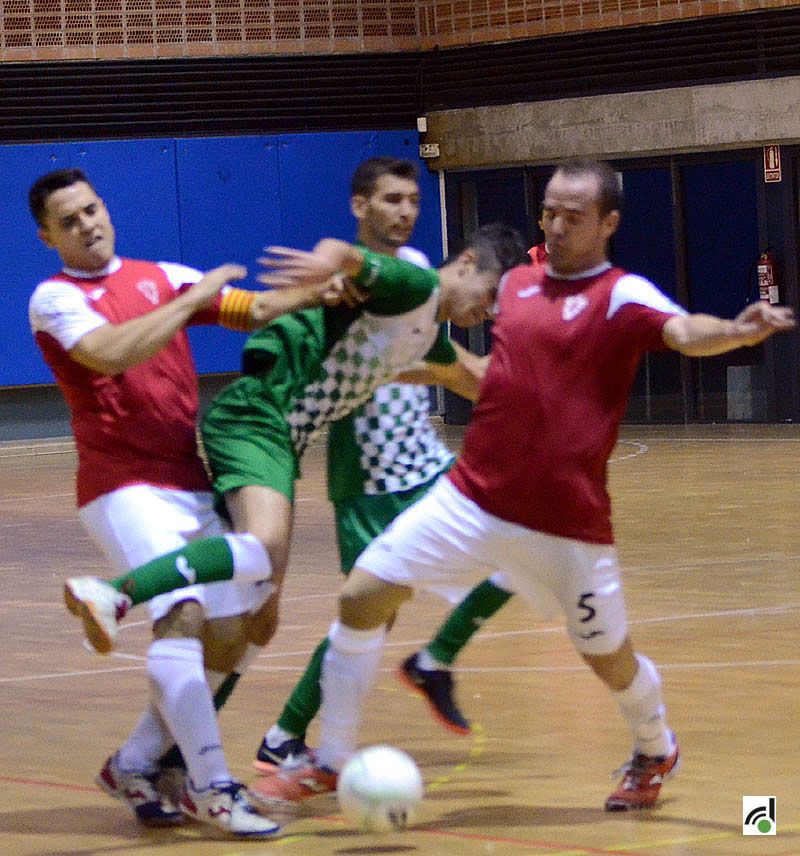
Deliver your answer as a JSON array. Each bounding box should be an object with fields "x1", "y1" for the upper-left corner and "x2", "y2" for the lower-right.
[{"x1": 0, "y1": 426, "x2": 800, "y2": 856}]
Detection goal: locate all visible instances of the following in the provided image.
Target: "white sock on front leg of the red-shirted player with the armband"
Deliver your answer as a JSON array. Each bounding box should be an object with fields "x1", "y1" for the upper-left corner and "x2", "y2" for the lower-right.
[{"x1": 147, "y1": 638, "x2": 231, "y2": 790}]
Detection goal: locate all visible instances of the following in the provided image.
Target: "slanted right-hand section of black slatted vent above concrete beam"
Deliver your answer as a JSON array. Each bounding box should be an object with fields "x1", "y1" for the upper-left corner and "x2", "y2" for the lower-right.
[{"x1": 425, "y1": 8, "x2": 800, "y2": 110}]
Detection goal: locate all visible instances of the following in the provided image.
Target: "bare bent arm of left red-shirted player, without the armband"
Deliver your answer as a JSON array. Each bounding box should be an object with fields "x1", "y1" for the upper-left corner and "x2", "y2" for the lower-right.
[{"x1": 69, "y1": 264, "x2": 247, "y2": 375}]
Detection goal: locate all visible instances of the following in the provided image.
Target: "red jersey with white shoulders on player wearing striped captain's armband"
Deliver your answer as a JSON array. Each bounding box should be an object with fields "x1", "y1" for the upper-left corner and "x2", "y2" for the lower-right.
[{"x1": 29, "y1": 258, "x2": 219, "y2": 506}]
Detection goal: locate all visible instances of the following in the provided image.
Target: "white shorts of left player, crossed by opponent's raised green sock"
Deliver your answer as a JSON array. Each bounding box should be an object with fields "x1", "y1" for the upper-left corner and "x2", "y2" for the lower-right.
[{"x1": 78, "y1": 484, "x2": 272, "y2": 621}]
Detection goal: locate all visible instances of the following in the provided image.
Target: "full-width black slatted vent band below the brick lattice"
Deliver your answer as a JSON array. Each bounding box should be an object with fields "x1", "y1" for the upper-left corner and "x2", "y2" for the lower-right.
[{"x1": 0, "y1": 7, "x2": 800, "y2": 142}]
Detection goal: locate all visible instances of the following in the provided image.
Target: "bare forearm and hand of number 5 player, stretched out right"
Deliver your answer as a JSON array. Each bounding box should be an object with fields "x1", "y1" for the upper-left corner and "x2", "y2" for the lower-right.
[{"x1": 662, "y1": 301, "x2": 796, "y2": 357}]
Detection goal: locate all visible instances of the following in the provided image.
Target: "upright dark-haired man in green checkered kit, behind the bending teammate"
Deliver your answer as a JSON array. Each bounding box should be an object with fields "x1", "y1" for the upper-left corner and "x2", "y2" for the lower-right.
[{"x1": 255, "y1": 157, "x2": 494, "y2": 773}]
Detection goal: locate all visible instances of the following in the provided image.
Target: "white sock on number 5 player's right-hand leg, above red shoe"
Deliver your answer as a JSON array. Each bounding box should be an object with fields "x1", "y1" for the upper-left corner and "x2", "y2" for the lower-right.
[{"x1": 613, "y1": 654, "x2": 673, "y2": 756}]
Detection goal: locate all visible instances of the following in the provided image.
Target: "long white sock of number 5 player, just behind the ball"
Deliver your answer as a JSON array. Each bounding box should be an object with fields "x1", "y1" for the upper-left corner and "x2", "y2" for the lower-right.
[{"x1": 316, "y1": 621, "x2": 386, "y2": 770}]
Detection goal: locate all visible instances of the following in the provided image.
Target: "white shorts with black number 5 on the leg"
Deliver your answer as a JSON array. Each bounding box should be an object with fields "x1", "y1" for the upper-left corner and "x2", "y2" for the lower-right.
[{"x1": 356, "y1": 478, "x2": 628, "y2": 654}]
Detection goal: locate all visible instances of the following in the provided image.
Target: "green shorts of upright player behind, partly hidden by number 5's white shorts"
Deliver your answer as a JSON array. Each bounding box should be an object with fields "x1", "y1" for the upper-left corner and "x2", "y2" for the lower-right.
[{"x1": 334, "y1": 475, "x2": 439, "y2": 575}]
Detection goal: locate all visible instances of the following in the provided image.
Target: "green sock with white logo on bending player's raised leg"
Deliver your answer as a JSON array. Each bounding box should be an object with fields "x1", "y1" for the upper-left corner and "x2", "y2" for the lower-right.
[{"x1": 109, "y1": 535, "x2": 233, "y2": 604}]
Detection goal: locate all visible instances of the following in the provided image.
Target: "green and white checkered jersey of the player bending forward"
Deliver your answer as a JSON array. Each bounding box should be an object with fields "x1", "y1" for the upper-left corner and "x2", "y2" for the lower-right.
[{"x1": 205, "y1": 250, "x2": 456, "y2": 457}]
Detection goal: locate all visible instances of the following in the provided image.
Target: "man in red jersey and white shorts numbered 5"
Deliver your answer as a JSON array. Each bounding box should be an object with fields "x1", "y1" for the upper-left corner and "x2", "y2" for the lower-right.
[{"x1": 252, "y1": 161, "x2": 794, "y2": 811}]
